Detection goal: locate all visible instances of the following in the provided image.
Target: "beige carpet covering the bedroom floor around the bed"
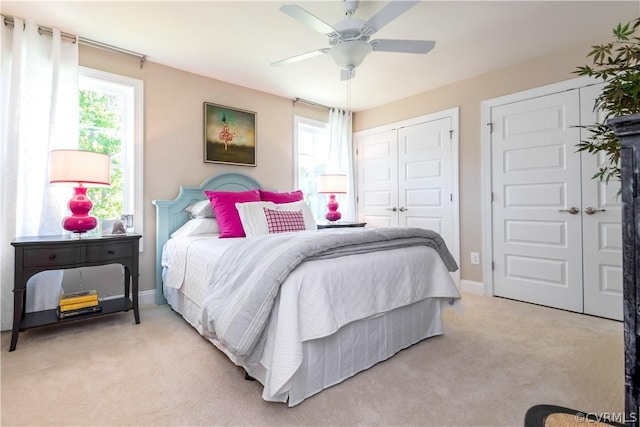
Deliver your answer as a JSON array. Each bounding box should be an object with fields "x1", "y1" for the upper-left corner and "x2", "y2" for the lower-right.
[{"x1": 1, "y1": 295, "x2": 624, "y2": 426}]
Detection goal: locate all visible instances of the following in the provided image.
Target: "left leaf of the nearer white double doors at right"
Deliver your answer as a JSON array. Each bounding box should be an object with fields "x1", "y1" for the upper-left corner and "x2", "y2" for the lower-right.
[{"x1": 491, "y1": 91, "x2": 583, "y2": 312}]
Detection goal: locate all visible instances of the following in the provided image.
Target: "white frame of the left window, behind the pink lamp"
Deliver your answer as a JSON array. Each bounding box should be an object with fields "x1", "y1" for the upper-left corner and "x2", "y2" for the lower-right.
[{"x1": 78, "y1": 66, "x2": 144, "y2": 252}]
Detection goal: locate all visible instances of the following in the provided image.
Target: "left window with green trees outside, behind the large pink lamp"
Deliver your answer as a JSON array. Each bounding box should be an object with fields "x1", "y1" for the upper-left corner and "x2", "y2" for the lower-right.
[{"x1": 78, "y1": 67, "x2": 143, "y2": 249}]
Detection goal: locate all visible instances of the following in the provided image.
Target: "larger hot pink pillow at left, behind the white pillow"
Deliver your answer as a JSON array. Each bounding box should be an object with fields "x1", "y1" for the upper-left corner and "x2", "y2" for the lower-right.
[{"x1": 204, "y1": 189, "x2": 260, "y2": 238}]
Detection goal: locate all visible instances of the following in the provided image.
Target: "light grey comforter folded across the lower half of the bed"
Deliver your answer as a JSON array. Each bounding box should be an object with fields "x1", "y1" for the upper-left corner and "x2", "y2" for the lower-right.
[{"x1": 202, "y1": 231, "x2": 458, "y2": 356}]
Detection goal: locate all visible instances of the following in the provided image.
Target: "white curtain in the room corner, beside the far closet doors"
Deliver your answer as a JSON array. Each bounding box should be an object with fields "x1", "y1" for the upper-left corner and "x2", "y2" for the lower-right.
[{"x1": 327, "y1": 108, "x2": 356, "y2": 221}]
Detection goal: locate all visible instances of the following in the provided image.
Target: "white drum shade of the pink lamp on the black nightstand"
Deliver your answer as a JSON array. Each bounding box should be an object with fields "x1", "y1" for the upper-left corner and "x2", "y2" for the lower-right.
[{"x1": 49, "y1": 150, "x2": 111, "y2": 186}]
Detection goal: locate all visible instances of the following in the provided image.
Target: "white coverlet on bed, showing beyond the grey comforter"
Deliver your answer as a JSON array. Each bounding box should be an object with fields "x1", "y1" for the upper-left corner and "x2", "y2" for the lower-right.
[{"x1": 163, "y1": 231, "x2": 460, "y2": 401}]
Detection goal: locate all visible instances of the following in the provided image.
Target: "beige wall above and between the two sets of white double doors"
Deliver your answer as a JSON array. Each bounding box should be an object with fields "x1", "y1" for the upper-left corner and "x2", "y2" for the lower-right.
[{"x1": 353, "y1": 42, "x2": 590, "y2": 282}]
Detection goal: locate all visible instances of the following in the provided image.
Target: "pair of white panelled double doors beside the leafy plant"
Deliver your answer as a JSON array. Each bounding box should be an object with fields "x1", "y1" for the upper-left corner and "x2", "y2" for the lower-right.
[{"x1": 491, "y1": 85, "x2": 622, "y2": 320}]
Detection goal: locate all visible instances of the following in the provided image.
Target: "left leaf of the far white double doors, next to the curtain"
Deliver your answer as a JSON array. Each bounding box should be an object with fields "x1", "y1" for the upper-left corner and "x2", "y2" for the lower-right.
[{"x1": 355, "y1": 129, "x2": 398, "y2": 227}]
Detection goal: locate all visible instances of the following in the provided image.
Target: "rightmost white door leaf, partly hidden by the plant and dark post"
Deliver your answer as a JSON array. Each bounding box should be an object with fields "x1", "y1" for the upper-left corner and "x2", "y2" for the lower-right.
[{"x1": 580, "y1": 85, "x2": 622, "y2": 320}]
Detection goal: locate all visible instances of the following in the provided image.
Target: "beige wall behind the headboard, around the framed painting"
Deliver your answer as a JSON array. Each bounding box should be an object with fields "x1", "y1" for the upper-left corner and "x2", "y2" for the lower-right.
[{"x1": 80, "y1": 46, "x2": 328, "y2": 298}]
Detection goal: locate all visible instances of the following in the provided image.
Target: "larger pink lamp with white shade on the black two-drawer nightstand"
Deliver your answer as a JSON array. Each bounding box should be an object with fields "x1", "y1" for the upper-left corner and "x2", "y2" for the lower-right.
[{"x1": 49, "y1": 150, "x2": 111, "y2": 233}]
